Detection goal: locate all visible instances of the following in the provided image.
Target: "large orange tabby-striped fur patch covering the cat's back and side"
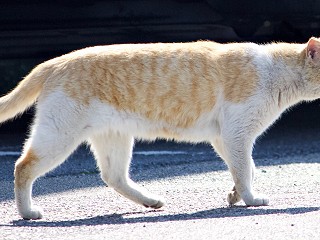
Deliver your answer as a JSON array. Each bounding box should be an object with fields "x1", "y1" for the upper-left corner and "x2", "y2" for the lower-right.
[{"x1": 46, "y1": 42, "x2": 257, "y2": 128}]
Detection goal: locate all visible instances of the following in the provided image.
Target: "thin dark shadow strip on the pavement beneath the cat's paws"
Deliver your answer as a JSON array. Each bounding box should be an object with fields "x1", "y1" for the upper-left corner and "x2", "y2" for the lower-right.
[{"x1": 7, "y1": 207, "x2": 320, "y2": 227}]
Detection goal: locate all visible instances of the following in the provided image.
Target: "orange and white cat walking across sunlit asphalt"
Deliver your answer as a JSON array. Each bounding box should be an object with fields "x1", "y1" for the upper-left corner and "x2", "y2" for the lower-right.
[{"x1": 0, "y1": 37, "x2": 320, "y2": 219}]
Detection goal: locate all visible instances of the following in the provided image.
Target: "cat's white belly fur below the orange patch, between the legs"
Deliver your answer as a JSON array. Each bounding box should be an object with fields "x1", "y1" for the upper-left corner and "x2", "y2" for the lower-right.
[{"x1": 88, "y1": 103, "x2": 220, "y2": 142}]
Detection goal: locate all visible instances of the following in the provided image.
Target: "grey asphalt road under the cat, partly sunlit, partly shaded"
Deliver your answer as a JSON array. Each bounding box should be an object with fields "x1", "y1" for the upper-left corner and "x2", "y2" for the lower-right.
[{"x1": 0, "y1": 123, "x2": 320, "y2": 240}]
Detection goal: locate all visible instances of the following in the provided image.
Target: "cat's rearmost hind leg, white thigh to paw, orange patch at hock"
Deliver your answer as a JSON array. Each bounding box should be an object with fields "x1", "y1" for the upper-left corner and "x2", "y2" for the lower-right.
[{"x1": 14, "y1": 98, "x2": 85, "y2": 219}]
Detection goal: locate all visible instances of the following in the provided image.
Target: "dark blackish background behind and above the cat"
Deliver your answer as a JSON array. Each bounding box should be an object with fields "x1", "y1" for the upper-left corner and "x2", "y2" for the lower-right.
[{"x1": 0, "y1": 0, "x2": 320, "y2": 133}]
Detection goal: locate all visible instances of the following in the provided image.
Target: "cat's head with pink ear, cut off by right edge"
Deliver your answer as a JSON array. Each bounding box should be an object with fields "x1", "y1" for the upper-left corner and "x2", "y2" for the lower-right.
[{"x1": 304, "y1": 37, "x2": 320, "y2": 99}]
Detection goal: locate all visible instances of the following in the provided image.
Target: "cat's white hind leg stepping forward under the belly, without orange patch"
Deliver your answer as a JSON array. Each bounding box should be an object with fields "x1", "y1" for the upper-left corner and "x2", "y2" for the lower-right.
[{"x1": 89, "y1": 132, "x2": 164, "y2": 208}]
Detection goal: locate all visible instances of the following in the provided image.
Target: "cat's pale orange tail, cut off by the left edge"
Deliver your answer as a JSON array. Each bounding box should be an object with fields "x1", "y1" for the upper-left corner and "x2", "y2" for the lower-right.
[{"x1": 0, "y1": 65, "x2": 47, "y2": 123}]
